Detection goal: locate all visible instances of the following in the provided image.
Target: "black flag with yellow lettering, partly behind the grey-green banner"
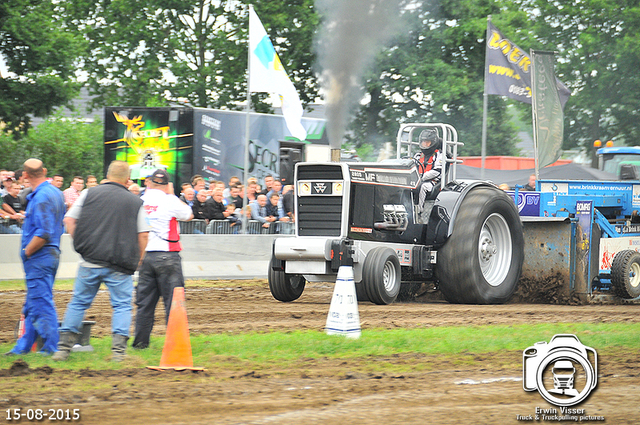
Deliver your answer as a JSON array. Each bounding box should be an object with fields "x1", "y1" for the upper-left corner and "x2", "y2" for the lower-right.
[{"x1": 485, "y1": 21, "x2": 571, "y2": 108}]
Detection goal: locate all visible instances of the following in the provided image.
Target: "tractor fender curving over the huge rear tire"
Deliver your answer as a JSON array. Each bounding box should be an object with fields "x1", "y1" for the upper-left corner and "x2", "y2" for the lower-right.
[{"x1": 425, "y1": 181, "x2": 496, "y2": 249}]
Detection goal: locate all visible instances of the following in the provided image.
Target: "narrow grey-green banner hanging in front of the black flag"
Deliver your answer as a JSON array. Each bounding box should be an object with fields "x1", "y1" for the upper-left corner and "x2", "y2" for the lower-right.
[{"x1": 531, "y1": 50, "x2": 564, "y2": 168}]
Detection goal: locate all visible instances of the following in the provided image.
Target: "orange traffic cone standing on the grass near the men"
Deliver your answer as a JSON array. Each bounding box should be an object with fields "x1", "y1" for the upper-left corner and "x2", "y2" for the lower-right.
[{"x1": 147, "y1": 287, "x2": 204, "y2": 370}]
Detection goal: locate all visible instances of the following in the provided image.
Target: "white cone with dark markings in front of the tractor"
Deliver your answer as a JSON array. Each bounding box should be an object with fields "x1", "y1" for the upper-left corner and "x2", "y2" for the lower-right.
[{"x1": 325, "y1": 266, "x2": 360, "y2": 338}]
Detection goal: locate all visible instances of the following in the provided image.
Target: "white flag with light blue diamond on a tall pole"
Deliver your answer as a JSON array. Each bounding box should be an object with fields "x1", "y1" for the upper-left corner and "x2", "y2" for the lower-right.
[{"x1": 249, "y1": 7, "x2": 307, "y2": 140}]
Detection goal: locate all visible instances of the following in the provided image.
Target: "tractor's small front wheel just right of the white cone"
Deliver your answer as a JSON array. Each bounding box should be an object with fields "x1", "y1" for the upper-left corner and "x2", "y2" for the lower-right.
[{"x1": 362, "y1": 246, "x2": 401, "y2": 305}]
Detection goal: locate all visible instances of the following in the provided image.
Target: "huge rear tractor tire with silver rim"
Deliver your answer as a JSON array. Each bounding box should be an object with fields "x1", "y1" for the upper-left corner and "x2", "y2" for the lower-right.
[{"x1": 436, "y1": 186, "x2": 524, "y2": 304}]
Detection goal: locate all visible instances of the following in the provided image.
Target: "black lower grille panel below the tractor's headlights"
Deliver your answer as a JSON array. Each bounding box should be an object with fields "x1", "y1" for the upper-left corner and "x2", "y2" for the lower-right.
[{"x1": 297, "y1": 196, "x2": 342, "y2": 236}]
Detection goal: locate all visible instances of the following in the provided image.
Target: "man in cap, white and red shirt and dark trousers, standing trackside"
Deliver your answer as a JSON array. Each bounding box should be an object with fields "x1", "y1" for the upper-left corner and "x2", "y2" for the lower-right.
[{"x1": 133, "y1": 169, "x2": 193, "y2": 349}]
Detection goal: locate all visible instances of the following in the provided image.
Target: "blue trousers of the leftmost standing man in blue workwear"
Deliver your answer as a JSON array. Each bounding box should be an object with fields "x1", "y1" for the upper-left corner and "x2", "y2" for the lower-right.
[{"x1": 11, "y1": 246, "x2": 60, "y2": 354}]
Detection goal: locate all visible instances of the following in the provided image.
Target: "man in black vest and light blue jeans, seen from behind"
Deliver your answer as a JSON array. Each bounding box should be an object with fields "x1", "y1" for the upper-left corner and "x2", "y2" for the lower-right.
[{"x1": 52, "y1": 161, "x2": 150, "y2": 361}]
